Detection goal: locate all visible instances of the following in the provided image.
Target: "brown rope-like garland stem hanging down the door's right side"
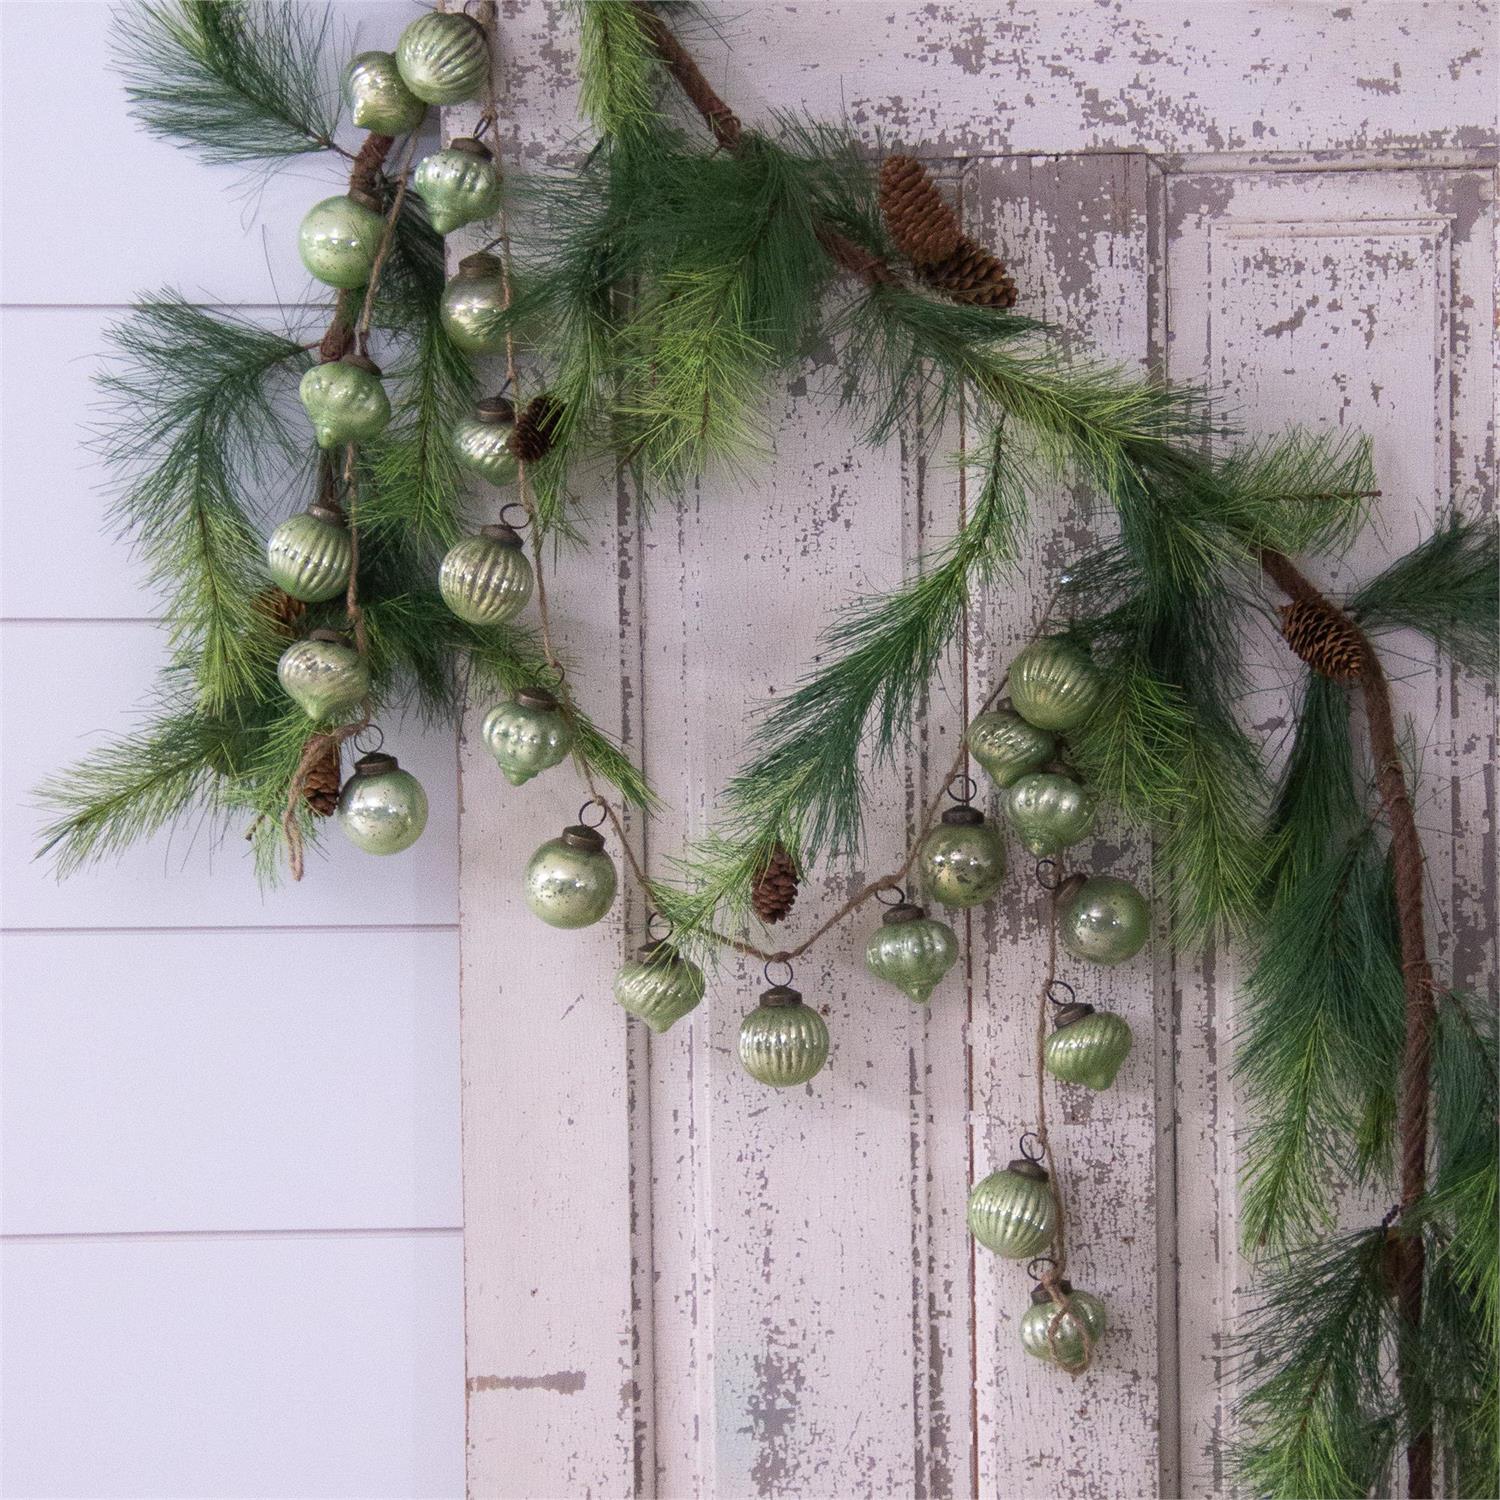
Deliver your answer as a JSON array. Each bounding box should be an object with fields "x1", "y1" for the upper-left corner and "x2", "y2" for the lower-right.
[{"x1": 1260, "y1": 549, "x2": 1437, "y2": 1500}]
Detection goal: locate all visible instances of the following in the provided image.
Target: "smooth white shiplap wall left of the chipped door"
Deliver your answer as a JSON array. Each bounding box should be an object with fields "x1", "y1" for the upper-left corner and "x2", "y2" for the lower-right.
[{"x1": 0, "y1": 0, "x2": 464, "y2": 1500}]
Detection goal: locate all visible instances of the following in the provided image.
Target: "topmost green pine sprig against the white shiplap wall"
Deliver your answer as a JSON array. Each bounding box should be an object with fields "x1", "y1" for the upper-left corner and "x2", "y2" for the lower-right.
[{"x1": 111, "y1": 0, "x2": 347, "y2": 164}]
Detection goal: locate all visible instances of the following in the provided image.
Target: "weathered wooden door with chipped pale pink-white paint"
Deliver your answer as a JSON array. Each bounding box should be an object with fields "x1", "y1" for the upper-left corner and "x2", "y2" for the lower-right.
[{"x1": 458, "y1": 0, "x2": 1496, "y2": 1497}]
